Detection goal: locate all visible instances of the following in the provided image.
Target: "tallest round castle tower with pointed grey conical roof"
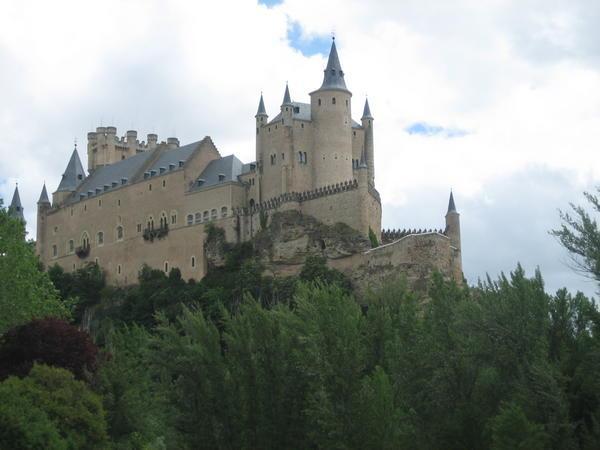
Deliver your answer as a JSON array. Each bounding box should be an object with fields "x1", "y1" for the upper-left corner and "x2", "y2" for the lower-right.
[{"x1": 310, "y1": 39, "x2": 352, "y2": 187}]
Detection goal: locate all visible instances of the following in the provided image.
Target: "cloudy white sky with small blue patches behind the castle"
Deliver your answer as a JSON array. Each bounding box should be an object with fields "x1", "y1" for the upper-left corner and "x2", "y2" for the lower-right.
[{"x1": 0, "y1": 0, "x2": 600, "y2": 295}]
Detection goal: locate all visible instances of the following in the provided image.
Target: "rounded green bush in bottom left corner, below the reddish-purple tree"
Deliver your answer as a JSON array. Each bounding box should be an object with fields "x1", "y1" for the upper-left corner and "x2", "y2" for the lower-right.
[{"x1": 0, "y1": 365, "x2": 108, "y2": 449}]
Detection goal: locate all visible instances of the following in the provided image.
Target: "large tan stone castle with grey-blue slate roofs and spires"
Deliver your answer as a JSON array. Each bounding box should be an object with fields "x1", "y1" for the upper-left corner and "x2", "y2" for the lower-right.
[{"x1": 9, "y1": 41, "x2": 462, "y2": 290}]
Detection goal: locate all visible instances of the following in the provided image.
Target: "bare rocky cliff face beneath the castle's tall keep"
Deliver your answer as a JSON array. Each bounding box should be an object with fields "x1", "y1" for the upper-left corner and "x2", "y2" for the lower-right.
[{"x1": 254, "y1": 210, "x2": 371, "y2": 265}]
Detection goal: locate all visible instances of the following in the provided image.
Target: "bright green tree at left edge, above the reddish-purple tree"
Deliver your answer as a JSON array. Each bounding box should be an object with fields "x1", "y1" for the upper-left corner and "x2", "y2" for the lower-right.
[{"x1": 0, "y1": 207, "x2": 69, "y2": 334}]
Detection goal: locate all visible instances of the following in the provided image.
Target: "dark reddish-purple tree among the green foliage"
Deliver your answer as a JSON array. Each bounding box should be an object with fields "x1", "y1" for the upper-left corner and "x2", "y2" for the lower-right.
[{"x1": 0, "y1": 318, "x2": 98, "y2": 381}]
